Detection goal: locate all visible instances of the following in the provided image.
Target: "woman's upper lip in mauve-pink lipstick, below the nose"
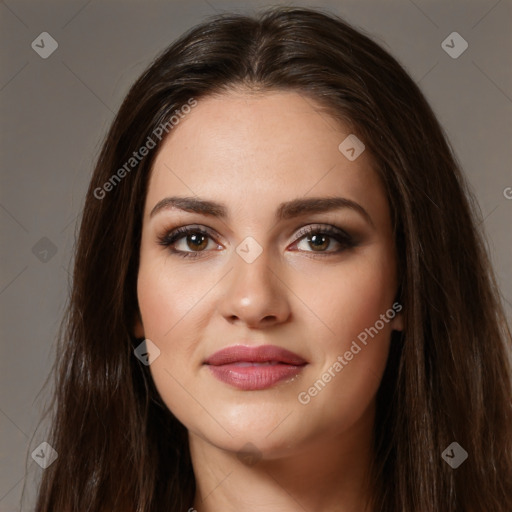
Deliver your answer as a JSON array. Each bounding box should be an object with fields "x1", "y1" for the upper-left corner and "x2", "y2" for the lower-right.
[{"x1": 205, "y1": 345, "x2": 307, "y2": 366}]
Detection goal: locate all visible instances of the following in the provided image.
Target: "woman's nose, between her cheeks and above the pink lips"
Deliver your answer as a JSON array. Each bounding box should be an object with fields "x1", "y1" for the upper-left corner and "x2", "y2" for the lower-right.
[{"x1": 220, "y1": 250, "x2": 291, "y2": 329}]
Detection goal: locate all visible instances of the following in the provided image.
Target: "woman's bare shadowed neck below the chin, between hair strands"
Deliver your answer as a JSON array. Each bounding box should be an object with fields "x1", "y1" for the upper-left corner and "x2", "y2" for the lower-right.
[{"x1": 189, "y1": 404, "x2": 375, "y2": 512}]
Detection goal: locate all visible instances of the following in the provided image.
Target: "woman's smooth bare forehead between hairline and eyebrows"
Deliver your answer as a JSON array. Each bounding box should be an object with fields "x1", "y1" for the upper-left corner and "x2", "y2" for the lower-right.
[{"x1": 147, "y1": 91, "x2": 383, "y2": 220}]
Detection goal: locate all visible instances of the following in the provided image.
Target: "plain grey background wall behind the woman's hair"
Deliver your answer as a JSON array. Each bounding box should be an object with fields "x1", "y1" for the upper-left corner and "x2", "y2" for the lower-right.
[{"x1": 0, "y1": 0, "x2": 512, "y2": 512}]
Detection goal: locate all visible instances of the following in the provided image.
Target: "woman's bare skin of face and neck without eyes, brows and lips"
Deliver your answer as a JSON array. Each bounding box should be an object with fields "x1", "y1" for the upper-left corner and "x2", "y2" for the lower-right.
[{"x1": 135, "y1": 91, "x2": 403, "y2": 512}]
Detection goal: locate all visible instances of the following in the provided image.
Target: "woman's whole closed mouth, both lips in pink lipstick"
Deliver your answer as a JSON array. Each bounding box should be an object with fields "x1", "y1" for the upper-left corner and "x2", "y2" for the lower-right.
[{"x1": 204, "y1": 345, "x2": 307, "y2": 391}]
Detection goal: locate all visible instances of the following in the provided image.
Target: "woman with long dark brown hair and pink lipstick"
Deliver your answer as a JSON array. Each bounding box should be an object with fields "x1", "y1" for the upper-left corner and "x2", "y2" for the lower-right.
[{"x1": 33, "y1": 8, "x2": 512, "y2": 512}]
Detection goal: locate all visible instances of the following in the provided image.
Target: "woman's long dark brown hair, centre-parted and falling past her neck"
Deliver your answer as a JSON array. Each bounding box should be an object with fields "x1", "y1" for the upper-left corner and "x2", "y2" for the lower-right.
[{"x1": 36, "y1": 7, "x2": 512, "y2": 512}]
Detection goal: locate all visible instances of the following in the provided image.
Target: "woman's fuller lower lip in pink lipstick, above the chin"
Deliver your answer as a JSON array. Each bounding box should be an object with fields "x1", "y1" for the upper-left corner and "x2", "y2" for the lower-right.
[{"x1": 208, "y1": 363, "x2": 304, "y2": 391}]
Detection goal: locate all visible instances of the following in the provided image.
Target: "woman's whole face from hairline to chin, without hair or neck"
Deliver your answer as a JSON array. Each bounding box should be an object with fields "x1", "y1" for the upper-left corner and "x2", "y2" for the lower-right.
[{"x1": 135, "y1": 92, "x2": 401, "y2": 459}]
